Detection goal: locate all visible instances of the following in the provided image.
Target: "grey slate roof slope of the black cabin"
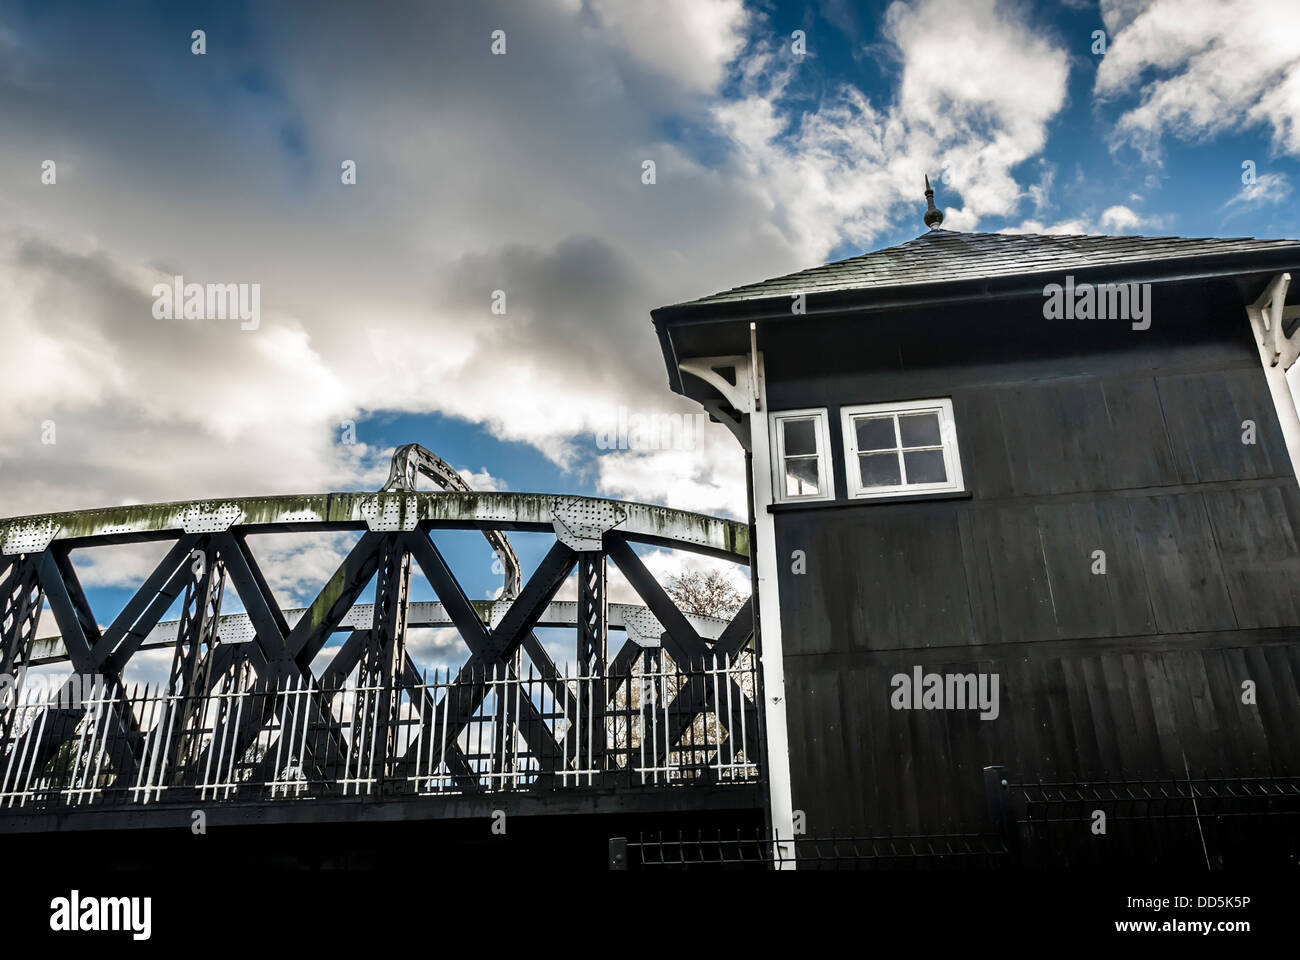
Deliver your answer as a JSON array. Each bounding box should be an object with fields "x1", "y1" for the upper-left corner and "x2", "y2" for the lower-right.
[{"x1": 676, "y1": 230, "x2": 1300, "y2": 307}]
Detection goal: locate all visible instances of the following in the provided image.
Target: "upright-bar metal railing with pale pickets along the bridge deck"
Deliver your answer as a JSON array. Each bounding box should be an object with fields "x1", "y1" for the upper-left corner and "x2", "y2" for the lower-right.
[{"x1": 0, "y1": 653, "x2": 759, "y2": 813}]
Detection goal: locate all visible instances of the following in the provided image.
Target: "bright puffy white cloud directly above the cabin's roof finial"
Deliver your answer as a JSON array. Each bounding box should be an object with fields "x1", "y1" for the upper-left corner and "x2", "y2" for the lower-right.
[{"x1": 714, "y1": 0, "x2": 1069, "y2": 254}]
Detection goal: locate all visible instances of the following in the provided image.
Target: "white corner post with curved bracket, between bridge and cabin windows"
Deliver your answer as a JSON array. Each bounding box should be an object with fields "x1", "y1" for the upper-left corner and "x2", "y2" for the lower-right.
[{"x1": 679, "y1": 343, "x2": 794, "y2": 870}]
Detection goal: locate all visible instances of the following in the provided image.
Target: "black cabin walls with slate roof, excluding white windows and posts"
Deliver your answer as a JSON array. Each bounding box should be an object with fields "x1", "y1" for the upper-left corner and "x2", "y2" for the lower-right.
[{"x1": 655, "y1": 223, "x2": 1300, "y2": 853}]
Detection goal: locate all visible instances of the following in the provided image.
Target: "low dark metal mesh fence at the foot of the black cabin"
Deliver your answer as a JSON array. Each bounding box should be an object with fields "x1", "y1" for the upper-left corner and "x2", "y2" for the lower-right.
[{"x1": 610, "y1": 766, "x2": 1300, "y2": 872}]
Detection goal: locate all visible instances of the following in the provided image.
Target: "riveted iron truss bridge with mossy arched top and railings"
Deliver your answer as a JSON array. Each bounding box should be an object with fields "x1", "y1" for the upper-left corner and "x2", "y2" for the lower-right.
[{"x1": 0, "y1": 445, "x2": 762, "y2": 833}]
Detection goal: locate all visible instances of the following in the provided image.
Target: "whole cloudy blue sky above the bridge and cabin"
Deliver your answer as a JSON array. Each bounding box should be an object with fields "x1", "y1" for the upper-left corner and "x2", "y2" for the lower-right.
[{"x1": 0, "y1": 0, "x2": 1300, "y2": 662}]
